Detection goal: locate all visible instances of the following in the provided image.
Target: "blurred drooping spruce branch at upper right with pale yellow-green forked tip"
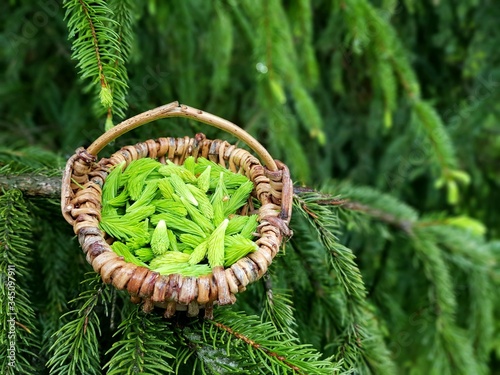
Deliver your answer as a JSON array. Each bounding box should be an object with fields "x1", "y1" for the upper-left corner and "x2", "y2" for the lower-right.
[{"x1": 341, "y1": 0, "x2": 470, "y2": 204}]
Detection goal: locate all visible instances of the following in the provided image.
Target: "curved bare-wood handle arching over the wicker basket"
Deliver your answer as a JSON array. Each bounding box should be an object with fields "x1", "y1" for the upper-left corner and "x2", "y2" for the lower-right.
[{"x1": 87, "y1": 101, "x2": 278, "y2": 171}]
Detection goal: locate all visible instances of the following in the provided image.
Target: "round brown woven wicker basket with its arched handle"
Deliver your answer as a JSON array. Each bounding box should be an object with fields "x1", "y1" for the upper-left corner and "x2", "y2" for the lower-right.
[{"x1": 61, "y1": 102, "x2": 292, "y2": 317}]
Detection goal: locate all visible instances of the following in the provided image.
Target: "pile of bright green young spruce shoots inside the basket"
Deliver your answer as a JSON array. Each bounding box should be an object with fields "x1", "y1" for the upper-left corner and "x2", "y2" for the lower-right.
[{"x1": 100, "y1": 156, "x2": 258, "y2": 277}]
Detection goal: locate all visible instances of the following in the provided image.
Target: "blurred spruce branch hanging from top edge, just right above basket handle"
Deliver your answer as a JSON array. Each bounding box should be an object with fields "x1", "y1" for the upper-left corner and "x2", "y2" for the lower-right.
[{"x1": 231, "y1": 0, "x2": 325, "y2": 180}]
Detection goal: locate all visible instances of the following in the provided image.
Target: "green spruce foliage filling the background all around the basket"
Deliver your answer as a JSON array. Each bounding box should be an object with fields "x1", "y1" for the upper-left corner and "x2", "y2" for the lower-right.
[{"x1": 0, "y1": 0, "x2": 500, "y2": 375}]
